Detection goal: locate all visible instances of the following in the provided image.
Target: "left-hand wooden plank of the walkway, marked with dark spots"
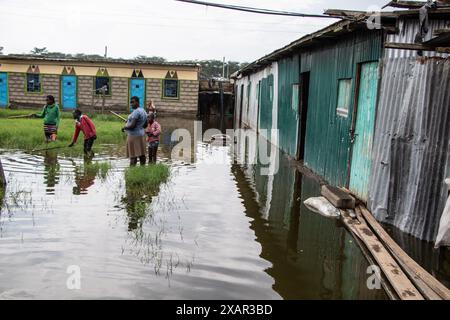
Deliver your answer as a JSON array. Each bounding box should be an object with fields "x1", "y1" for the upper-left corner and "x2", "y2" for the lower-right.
[{"x1": 342, "y1": 212, "x2": 424, "y2": 300}]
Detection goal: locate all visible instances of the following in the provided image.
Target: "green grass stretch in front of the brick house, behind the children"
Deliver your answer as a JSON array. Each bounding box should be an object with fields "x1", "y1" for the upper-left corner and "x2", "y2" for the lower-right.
[{"x1": 0, "y1": 109, "x2": 126, "y2": 154}]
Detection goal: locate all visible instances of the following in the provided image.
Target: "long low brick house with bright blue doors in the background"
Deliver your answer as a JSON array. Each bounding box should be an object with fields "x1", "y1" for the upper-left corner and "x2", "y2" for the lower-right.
[{"x1": 0, "y1": 55, "x2": 199, "y2": 114}]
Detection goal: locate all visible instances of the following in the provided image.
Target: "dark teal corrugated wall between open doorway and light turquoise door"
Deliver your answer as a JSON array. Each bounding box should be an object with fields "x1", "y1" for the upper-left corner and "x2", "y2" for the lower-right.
[{"x1": 300, "y1": 32, "x2": 382, "y2": 186}]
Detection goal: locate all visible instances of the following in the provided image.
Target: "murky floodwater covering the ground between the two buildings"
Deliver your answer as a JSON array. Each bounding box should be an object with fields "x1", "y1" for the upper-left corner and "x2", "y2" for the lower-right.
[{"x1": 0, "y1": 118, "x2": 386, "y2": 299}]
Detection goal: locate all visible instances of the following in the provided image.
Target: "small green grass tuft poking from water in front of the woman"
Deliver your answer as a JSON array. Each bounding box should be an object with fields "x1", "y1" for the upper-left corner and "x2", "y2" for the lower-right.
[{"x1": 125, "y1": 163, "x2": 170, "y2": 193}]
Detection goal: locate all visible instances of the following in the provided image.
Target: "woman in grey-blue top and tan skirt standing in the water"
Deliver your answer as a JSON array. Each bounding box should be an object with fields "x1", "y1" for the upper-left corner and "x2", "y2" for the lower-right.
[{"x1": 122, "y1": 97, "x2": 147, "y2": 167}]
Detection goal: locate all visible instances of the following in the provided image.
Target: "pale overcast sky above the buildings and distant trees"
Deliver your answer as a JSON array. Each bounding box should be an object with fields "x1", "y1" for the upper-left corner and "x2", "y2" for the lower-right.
[{"x1": 0, "y1": 0, "x2": 388, "y2": 62}]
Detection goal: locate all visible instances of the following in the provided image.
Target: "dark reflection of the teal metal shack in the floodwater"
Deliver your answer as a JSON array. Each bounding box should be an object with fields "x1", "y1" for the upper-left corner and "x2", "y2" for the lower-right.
[{"x1": 232, "y1": 140, "x2": 387, "y2": 299}]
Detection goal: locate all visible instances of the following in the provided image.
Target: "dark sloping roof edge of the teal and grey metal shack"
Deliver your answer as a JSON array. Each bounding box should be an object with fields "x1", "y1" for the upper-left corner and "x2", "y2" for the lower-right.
[{"x1": 231, "y1": 6, "x2": 450, "y2": 79}]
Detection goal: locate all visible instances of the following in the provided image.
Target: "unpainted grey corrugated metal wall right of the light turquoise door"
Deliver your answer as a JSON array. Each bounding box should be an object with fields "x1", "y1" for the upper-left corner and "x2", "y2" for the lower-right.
[{"x1": 369, "y1": 57, "x2": 450, "y2": 241}]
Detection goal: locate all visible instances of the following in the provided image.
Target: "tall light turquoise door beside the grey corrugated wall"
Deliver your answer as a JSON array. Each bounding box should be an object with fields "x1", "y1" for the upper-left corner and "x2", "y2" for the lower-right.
[{"x1": 350, "y1": 62, "x2": 378, "y2": 200}]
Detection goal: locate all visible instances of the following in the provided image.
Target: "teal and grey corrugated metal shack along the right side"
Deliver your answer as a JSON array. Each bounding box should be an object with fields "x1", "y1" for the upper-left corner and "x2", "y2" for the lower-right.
[{"x1": 234, "y1": 8, "x2": 450, "y2": 241}]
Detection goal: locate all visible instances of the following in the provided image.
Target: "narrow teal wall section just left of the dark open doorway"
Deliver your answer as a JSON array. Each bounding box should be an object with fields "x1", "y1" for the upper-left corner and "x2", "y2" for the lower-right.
[{"x1": 278, "y1": 55, "x2": 300, "y2": 157}]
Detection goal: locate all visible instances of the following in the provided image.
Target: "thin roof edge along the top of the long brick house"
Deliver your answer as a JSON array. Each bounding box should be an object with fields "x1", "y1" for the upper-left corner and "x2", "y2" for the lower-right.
[{"x1": 0, "y1": 54, "x2": 200, "y2": 68}]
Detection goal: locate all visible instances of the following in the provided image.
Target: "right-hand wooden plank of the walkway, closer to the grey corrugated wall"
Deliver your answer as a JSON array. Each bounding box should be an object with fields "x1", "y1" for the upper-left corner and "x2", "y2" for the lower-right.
[{"x1": 360, "y1": 206, "x2": 450, "y2": 300}]
